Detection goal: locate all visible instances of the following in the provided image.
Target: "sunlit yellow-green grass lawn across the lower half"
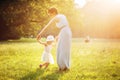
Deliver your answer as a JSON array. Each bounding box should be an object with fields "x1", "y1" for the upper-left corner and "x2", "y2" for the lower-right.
[{"x1": 0, "y1": 39, "x2": 120, "y2": 80}]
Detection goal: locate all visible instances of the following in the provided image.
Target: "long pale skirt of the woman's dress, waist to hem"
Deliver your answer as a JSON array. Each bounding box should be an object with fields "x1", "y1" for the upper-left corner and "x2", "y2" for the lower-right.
[{"x1": 57, "y1": 27, "x2": 72, "y2": 69}]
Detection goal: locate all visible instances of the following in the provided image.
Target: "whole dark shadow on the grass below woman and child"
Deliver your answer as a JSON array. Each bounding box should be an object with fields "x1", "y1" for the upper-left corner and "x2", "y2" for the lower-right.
[{"x1": 20, "y1": 69, "x2": 66, "y2": 80}]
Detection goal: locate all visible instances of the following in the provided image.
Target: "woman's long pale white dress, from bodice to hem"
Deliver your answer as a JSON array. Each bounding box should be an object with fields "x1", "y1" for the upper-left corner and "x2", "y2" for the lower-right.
[{"x1": 55, "y1": 14, "x2": 72, "y2": 69}]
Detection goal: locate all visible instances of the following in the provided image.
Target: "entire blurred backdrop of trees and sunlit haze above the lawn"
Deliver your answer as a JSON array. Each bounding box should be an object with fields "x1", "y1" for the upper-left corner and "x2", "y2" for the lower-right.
[{"x1": 0, "y1": 0, "x2": 120, "y2": 40}]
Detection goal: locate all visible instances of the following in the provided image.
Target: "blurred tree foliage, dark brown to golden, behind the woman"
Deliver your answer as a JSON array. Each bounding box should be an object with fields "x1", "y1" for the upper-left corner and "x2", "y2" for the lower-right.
[{"x1": 0, "y1": 0, "x2": 81, "y2": 40}]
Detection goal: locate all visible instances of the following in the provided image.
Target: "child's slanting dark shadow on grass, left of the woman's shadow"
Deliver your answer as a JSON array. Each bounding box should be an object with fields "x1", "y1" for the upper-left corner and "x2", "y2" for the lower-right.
[{"x1": 20, "y1": 68, "x2": 45, "y2": 80}]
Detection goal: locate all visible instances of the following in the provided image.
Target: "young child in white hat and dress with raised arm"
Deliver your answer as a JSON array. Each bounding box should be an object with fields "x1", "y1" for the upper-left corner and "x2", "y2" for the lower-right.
[{"x1": 39, "y1": 35, "x2": 54, "y2": 68}]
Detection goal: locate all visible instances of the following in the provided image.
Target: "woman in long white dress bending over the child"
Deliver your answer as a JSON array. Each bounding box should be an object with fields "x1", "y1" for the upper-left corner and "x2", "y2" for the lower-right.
[{"x1": 37, "y1": 8, "x2": 72, "y2": 70}]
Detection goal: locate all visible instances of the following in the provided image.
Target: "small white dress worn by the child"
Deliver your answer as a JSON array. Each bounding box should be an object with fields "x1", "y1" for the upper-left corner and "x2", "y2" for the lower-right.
[{"x1": 42, "y1": 45, "x2": 54, "y2": 64}]
